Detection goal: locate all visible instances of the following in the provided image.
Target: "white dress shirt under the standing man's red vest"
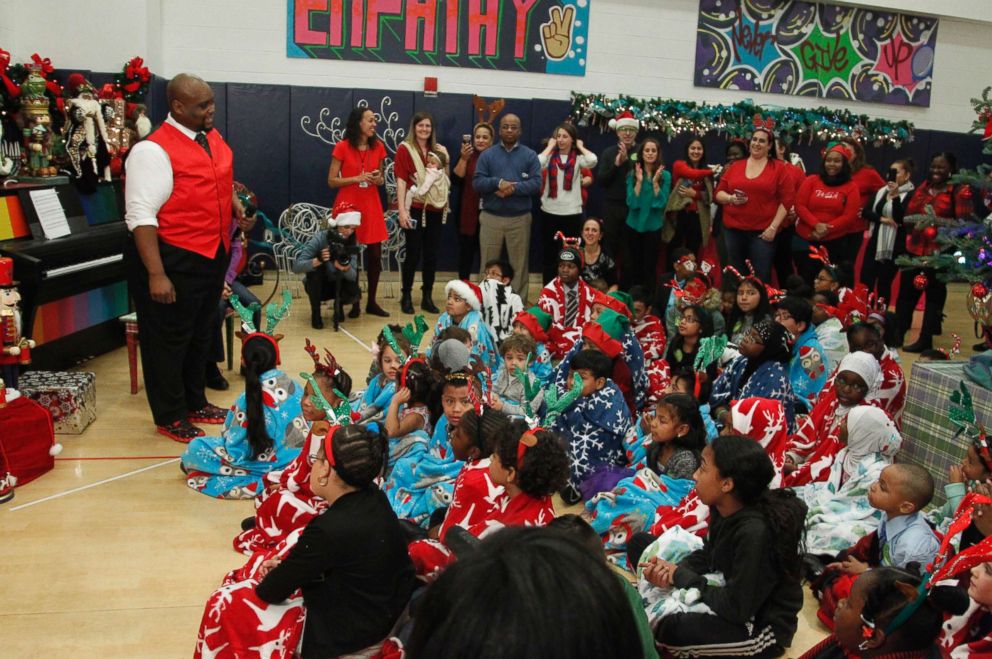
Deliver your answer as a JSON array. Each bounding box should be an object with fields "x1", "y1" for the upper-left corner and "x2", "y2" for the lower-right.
[{"x1": 124, "y1": 113, "x2": 197, "y2": 231}]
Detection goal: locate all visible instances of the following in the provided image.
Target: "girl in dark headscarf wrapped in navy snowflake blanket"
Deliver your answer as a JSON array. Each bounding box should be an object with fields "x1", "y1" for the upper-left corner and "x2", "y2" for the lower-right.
[{"x1": 709, "y1": 319, "x2": 795, "y2": 432}]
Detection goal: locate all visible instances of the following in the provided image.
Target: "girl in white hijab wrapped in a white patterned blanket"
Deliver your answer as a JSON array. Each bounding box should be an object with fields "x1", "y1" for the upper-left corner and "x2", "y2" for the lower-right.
[{"x1": 795, "y1": 405, "x2": 902, "y2": 554}]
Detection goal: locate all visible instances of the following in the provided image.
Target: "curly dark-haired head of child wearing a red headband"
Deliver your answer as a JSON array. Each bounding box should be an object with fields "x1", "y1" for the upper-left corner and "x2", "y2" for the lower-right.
[{"x1": 493, "y1": 420, "x2": 568, "y2": 498}]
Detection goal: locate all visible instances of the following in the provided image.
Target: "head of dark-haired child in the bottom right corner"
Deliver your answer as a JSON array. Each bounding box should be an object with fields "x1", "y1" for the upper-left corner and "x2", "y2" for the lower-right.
[{"x1": 849, "y1": 567, "x2": 969, "y2": 651}]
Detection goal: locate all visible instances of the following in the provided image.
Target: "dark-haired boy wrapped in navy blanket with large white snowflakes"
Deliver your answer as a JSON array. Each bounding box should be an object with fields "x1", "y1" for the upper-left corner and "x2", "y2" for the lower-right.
[{"x1": 552, "y1": 350, "x2": 630, "y2": 505}]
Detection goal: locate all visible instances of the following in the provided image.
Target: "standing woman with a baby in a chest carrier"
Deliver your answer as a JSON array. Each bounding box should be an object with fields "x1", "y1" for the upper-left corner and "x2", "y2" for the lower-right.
[{"x1": 394, "y1": 112, "x2": 451, "y2": 313}]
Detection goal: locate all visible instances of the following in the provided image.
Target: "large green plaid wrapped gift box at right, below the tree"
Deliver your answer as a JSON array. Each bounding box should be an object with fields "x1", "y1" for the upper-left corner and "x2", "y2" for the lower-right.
[{"x1": 898, "y1": 361, "x2": 992, "y2": 504}]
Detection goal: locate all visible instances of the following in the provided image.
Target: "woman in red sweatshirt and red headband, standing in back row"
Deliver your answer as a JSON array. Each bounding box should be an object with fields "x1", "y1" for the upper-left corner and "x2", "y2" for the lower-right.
[{"x1": 796, "y1": 142, "x2": 864, "y2": 281}]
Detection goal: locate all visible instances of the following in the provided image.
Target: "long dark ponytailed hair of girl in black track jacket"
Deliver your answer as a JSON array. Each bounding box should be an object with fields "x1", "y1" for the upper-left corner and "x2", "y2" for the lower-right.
[{"x1": 710, "y1": 435, "x2": 806, "y2": 581}]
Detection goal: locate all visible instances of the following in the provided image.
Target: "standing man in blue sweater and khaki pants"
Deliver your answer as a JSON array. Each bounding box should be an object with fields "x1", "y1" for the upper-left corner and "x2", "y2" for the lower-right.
[{"x1": 472, "y1": 114, "x2": 541, "y2": 306}]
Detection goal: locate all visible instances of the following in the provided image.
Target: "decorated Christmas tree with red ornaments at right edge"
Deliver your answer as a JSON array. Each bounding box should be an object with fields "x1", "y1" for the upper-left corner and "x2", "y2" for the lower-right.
[{"x1": 896, "y1": 87, "x2": 992, "y2": 345}]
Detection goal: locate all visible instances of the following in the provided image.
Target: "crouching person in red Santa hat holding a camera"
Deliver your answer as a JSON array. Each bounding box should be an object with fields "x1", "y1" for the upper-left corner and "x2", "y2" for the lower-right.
[{"x1": 293, "y1": 204, "x2": 362, "y2": 329}]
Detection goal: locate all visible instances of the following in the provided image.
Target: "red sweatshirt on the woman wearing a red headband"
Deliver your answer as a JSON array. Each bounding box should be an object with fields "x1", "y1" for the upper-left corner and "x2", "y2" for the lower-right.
[{"x1": 796, "y1": 174, "x2": 864, "y2": 241}]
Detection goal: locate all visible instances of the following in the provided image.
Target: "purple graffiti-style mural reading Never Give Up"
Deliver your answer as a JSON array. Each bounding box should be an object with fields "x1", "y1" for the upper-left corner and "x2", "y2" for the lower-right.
[{"x1": 695, "y1": 0, "x2": 937, "y2": 106}]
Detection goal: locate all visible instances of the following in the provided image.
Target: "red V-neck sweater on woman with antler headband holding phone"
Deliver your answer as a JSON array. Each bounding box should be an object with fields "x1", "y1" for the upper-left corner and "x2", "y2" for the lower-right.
[{"x1": 717, "y1": 158, "x2": 795, "y2": 231}]
